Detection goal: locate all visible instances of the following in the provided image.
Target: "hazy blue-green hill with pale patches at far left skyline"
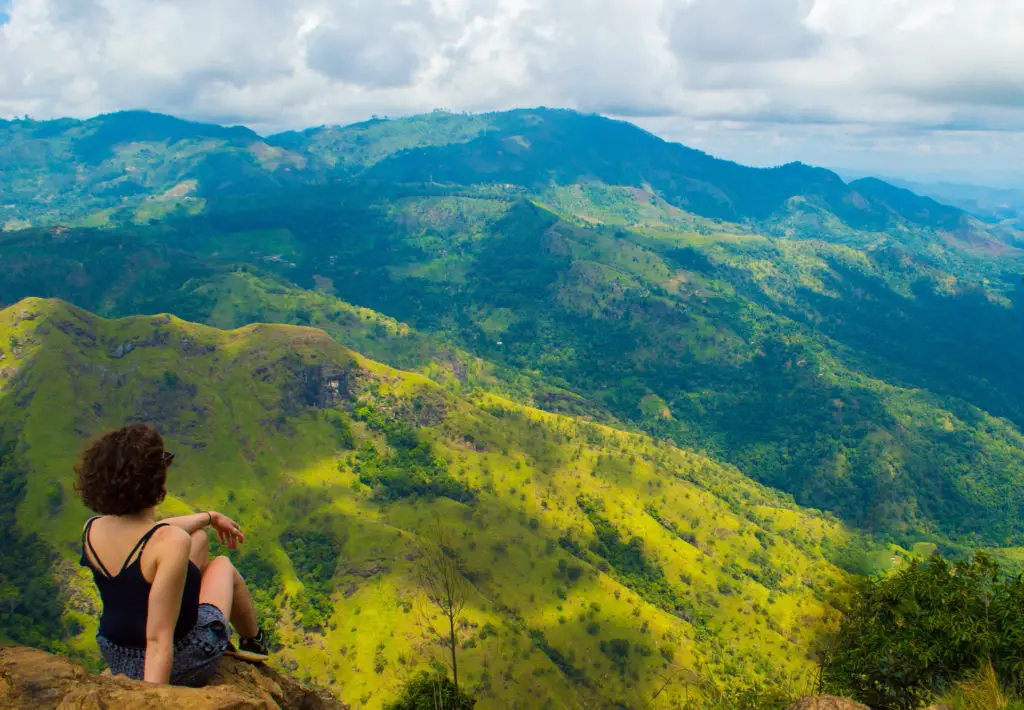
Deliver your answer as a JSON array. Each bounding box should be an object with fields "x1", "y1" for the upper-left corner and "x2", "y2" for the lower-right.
[{"x1": 0, "y1": 111, "x2": 304, "y2": 226}]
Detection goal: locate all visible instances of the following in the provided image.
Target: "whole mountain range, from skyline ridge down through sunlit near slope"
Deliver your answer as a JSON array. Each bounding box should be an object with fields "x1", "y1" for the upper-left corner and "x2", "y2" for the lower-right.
[{"x1": 0, "y1": 109, "x2": 1024, "y2": 707}]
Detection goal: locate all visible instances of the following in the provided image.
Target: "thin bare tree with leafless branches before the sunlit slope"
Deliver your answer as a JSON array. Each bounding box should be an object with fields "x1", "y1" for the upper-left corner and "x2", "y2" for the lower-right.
[{"x1": 416, "y1": 519, "x2": 469, "y2": 703}]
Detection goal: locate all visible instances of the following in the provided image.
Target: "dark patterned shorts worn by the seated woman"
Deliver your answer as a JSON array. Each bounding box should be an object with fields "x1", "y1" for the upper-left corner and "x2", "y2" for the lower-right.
[{"x1": 96, "y1": 604, "x2": 230, "y2": 687}]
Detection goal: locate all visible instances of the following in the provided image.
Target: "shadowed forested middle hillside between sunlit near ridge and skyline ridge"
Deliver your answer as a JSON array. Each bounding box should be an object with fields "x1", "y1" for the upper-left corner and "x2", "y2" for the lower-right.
[{"x1": 0, "y1": 185, "x2": 1024, "y2": 546}]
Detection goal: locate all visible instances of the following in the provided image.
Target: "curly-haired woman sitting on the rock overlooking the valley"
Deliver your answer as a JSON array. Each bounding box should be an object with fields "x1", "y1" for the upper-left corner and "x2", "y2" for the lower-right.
[{"x1": 75, "y1": 424, "x2": 267, "y2": 686}]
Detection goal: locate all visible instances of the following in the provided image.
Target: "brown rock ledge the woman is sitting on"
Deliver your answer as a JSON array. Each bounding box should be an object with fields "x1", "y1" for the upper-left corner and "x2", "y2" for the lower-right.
[{"x1": 0, "y1": 646, "x2": 348, "y2": 710}]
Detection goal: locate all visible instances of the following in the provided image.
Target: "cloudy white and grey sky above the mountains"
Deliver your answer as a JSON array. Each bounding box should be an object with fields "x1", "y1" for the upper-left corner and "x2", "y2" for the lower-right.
[{"x1": 0, "y1": 0, "x2": 1024, "y2": 186}]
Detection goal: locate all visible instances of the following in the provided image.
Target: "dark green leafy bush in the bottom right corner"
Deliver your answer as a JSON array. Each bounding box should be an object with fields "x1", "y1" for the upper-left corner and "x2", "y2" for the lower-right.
[{"x1": 823, "y1": 553, "x2": 1024, "y2": 710}]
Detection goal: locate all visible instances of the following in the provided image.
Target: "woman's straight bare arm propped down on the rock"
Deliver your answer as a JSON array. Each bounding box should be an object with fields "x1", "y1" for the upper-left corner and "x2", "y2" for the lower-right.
[{"x1": 143, "y1": 528, "x2": 191, "y2": 683}]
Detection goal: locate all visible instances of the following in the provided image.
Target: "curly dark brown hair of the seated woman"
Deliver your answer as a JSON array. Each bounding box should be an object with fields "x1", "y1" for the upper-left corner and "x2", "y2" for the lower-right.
[{"x1": 75, "y1": 424, "x2": 167, "y2": 515}]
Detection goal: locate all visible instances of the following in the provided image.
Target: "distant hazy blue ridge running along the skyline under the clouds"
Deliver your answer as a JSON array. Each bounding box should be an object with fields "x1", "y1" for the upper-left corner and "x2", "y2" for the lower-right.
[{"x1": 0, "y1": 109, "x2": 970, "y2": 231}]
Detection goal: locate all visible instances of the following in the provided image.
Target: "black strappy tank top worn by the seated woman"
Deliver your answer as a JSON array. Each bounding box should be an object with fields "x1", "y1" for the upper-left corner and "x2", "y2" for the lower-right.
[{"x1": 80, "y1": 517, "x2": 203, "y2": 650}]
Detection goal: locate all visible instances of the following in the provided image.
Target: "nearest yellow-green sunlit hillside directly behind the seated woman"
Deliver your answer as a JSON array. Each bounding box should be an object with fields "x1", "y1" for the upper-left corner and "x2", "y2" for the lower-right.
[{"x1": 0, "y1": 299, "x2": 855, "y2": 708}]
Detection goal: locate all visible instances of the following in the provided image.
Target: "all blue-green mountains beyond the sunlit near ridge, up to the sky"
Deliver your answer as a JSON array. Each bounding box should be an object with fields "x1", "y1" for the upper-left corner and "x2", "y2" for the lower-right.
[{"x1": 0, "y1": 110, "x2": 1024, "y2": 551}]
